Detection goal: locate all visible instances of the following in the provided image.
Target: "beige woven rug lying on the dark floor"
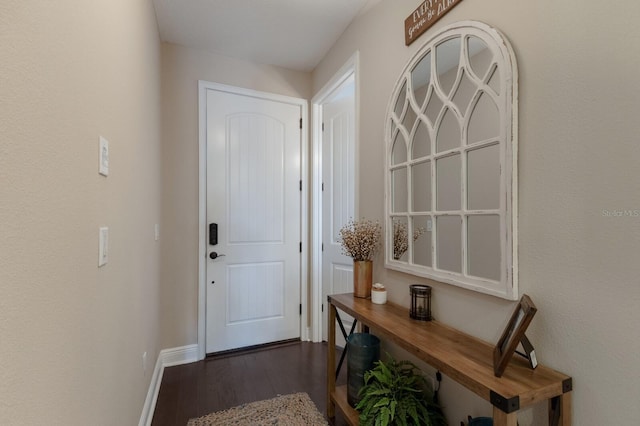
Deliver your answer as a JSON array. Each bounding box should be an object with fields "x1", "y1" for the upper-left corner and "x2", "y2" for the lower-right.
[{"x1": 187, "y1": 392, "x2": 328, "y2": 426}]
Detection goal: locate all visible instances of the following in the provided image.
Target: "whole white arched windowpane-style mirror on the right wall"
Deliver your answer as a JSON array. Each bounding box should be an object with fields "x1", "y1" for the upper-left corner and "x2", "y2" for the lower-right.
[{"x1": 385, "y1": 21, "x2": 518, "y2": 300}]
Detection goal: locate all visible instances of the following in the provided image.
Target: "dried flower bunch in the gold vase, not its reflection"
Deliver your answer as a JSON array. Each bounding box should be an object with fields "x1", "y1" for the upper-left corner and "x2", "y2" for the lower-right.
[{"x1": 340, "y1": 219, "x2": 382, "y2": 261}]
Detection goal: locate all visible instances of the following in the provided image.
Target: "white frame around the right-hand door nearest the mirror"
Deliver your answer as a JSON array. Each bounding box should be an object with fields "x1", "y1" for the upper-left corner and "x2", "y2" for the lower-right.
[{"x1": 311, "y1": 51, "x2": 360, "y2": 342}]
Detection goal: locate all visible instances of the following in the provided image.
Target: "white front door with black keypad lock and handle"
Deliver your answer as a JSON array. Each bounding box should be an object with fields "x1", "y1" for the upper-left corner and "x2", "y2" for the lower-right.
[{"x1": 206, "y1": 85, "x2": 301, "y2": 353}]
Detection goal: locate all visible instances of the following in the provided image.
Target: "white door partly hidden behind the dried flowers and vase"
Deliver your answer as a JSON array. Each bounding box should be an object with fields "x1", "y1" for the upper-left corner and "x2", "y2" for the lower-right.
[{"x1": 322, "y1": 82, "x2": 357, "y2": 345}]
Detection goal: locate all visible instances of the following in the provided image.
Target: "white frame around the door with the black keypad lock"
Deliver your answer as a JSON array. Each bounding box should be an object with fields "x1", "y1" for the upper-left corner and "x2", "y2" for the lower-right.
[{"x1": 198, "y1": 80, "x2": 310, "y2": 359}]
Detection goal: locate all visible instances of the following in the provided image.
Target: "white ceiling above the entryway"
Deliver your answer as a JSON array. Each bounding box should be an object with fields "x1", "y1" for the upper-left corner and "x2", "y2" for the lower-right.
[{"x1": 153, "y1": 0, "x2": 381, "y2": 71}]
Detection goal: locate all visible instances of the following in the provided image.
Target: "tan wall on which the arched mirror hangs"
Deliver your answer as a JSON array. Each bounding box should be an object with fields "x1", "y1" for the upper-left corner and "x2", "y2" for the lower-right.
[{"x1": 313, "y1": 0, "x2": 640, "y2": 426}]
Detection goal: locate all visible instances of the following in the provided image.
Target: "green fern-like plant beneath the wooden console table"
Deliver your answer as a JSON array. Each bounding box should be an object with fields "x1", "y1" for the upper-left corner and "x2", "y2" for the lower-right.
[{"x1": 356, "y1": 357, "x2": 447, "y2": 426}]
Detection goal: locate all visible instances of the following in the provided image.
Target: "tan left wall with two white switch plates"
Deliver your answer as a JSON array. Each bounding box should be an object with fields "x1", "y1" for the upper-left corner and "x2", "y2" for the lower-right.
[{"x1": 0, "y1": 0, "x2": 161, "y2": 425}]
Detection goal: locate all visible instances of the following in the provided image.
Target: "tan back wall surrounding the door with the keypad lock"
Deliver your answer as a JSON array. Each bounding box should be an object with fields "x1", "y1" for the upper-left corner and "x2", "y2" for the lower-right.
[{"x1": 161, "y1": 43, "x2": 311, "y2": 348}]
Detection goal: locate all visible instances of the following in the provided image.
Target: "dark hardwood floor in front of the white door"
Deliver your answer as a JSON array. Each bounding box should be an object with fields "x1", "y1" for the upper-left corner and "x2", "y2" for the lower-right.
[{"x1": 152, "y1": 342, "x2": 346, "y2": 426}]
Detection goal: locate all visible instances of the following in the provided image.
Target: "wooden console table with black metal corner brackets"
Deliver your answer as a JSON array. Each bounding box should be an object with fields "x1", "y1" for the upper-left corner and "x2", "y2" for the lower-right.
[{"x1": 327, "y1": 294, "x2": 572, "y2": 426}]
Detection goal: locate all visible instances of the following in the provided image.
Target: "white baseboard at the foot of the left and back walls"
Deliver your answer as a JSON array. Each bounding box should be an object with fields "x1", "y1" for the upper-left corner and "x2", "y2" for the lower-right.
[{"x1": 138, "y1": 345, "x2": 198, "y2": 426}]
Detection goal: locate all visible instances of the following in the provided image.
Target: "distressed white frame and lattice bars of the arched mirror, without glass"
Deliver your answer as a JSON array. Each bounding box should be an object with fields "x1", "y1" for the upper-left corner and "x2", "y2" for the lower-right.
[{"x1": 385, "y1": 21, "x2": 518, "y2": 300}]
